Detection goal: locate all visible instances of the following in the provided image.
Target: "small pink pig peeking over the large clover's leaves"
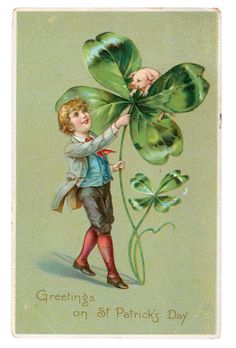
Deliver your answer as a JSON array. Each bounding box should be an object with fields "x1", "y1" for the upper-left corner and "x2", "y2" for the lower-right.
[{"x1": 128, "y1": 68, "x2": 161, "y2": 96}]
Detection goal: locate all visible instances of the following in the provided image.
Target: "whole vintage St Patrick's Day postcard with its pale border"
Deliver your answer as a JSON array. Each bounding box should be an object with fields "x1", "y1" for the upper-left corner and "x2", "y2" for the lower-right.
[{"x1": 12, "y1": 8, "x2": 221, "y2": 337}]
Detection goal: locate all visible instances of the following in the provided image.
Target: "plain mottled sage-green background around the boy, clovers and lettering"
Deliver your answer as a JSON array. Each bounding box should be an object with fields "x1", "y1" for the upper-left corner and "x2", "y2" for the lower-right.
[{"x1": 15, "y1": 11, "x2": 218, "y2": 334}]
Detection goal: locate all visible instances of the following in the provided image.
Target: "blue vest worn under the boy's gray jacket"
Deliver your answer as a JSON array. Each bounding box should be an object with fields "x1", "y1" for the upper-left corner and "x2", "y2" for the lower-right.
[{"x1": 79, "y1": 154, "x2": 113, "y2": 187}]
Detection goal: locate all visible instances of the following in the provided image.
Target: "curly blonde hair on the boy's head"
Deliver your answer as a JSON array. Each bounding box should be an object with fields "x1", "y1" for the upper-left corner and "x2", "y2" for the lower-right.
[{"x1": 58, "y1": 97, "x2": 88, "y2": 135}]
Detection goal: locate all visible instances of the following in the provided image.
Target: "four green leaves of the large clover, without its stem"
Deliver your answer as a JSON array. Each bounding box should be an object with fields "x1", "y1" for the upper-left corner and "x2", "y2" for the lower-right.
[{"x1": 56, "y1": 32, "x2": 209, "y2": 165}]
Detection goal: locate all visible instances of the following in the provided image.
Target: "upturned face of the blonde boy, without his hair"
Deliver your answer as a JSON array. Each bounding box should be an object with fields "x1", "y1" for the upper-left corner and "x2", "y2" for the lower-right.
[{"x1": 69, "y1": 110, "x2": 92, "y2": 133}]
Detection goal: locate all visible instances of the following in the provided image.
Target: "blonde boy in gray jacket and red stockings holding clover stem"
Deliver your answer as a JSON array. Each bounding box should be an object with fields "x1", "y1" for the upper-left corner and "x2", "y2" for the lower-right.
[{"x1": 52, "y1": 98, "x2": 130, "y2": 289}]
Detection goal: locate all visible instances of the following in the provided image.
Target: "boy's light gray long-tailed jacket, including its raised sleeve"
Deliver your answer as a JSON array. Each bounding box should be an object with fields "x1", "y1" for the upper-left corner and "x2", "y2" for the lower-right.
[{"x1": 52, "y1": 126, "x2": 116, "y2": 213}]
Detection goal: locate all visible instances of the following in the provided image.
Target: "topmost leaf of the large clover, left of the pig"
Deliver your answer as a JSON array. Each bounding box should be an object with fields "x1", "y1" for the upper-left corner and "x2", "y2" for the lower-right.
[{"x1": 83, "y1": 32, "x2": 142, "y2": 99}]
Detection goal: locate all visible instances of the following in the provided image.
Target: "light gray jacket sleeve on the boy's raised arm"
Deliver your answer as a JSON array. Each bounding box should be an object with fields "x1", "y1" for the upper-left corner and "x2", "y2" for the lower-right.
[{"x1": 65, "y1": 124, "x2": 118, "y2": 157}]
